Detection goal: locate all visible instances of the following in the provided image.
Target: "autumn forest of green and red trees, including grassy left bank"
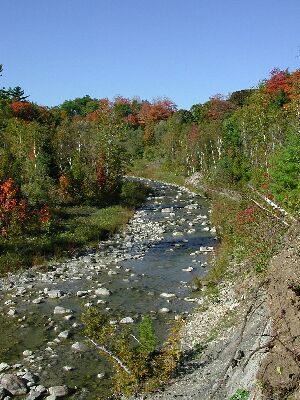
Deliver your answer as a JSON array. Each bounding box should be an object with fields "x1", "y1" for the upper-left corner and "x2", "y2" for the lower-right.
[{"x1": 0, "y1": 66, "x2": 300, "y2": 271}]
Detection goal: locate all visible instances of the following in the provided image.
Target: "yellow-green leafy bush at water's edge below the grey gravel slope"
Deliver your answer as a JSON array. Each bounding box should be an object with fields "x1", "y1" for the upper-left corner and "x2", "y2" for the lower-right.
[{"x1": 83, "y1": 308, "x2": 181, "y2": 395}]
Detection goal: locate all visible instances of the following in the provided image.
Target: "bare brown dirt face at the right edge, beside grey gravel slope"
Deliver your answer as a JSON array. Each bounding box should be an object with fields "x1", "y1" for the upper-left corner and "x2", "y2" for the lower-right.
[{"x1": 258, "y1": 225, "x2": 300, "y2": 400}]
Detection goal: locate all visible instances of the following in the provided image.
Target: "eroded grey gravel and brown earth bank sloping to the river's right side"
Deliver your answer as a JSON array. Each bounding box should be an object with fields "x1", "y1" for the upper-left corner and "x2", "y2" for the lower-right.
[{"x1": 125, "y1": 168, "x2": 300, "y2": 400}]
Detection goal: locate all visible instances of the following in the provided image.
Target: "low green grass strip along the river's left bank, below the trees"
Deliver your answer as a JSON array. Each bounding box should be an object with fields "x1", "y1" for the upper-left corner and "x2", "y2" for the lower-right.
[{"x1": 0, "y1": 182, "x2": 148, "y2": 275}]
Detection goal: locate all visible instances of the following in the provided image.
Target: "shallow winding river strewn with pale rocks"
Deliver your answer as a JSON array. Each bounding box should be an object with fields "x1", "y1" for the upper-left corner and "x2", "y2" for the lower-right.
[{"x1": 0, "y1": 181, "x2": 216, "y2": 400}]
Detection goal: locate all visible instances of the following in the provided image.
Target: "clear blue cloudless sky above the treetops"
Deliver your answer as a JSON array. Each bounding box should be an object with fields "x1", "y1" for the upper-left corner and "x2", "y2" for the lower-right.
[{"x1": 0, "y1": 0, "x2": 300, "y2": 109}]
